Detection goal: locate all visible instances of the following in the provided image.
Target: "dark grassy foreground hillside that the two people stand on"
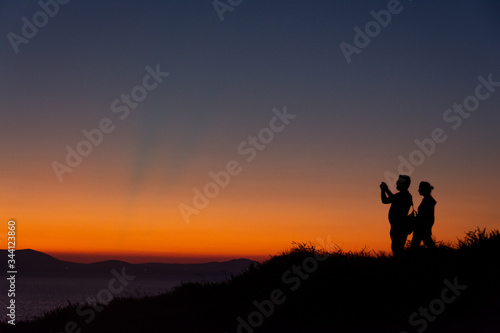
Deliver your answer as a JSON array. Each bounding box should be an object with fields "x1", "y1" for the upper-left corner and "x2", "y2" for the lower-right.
[{"x1": 0, "y1": 228, "x2": 500, "y2": 333}]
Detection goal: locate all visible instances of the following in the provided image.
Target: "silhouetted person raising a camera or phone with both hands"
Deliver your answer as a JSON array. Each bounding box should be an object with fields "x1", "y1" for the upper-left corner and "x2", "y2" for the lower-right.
[{"x1": 380, "y1": 175, "x2": 413, "y2": 256}]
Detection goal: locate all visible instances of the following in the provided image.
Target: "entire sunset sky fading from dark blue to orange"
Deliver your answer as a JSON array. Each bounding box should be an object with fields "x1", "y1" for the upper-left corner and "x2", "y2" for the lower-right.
[{"x1": 0, "y1": 0, "x2": 500, "y2": 262}]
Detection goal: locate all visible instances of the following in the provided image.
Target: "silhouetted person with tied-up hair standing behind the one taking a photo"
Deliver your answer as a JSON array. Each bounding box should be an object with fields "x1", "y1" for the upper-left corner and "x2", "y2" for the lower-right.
[{"x1": 411, "y1": 182, "x2": 436, "y2": 249}]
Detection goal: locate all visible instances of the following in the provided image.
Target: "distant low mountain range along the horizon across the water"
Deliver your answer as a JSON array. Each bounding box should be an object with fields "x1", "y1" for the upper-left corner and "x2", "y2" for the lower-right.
[{"x1": 0, "y1": 249, "x2": 253, "y2": 280}]
